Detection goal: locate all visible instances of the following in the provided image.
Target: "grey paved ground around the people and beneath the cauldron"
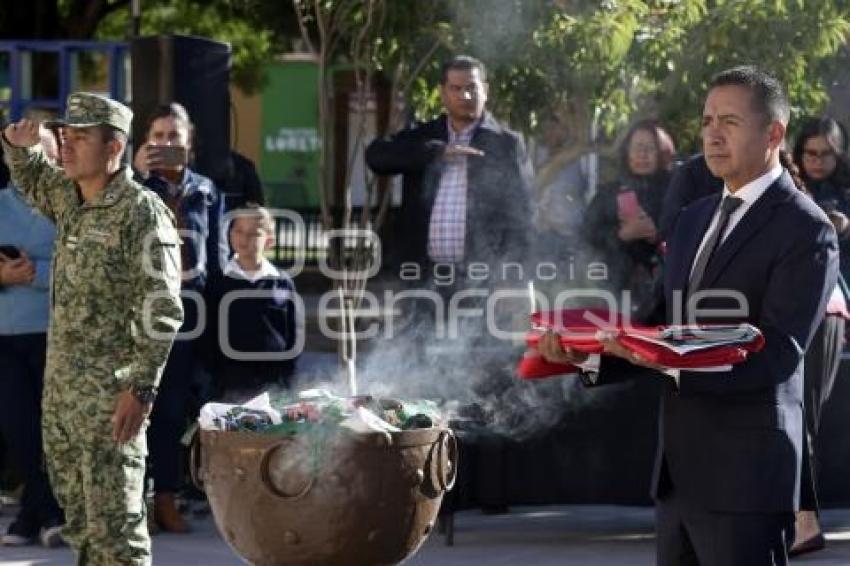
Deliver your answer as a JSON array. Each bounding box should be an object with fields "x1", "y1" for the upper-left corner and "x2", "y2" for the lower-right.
[{"x1": 0, "y1": 506, "x2": 850, "y2": 566}]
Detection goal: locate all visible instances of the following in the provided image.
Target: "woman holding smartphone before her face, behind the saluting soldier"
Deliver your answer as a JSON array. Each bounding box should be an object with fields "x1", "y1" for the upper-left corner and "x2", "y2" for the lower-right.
[{"x1": 133, "y1": 102, "x2": 228, "y2": 533}]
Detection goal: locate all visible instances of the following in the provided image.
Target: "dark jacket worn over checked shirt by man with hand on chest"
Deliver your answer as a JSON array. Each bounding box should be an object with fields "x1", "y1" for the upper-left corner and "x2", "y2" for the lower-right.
[{"x1": 366, "y1": 112, "x2": 531, "y2": 270}]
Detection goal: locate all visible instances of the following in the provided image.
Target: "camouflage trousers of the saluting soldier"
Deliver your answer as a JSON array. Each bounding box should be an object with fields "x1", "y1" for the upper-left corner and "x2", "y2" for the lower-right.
[{"x1": 42, "y1": 385, "x2": 151, "y2": 566}]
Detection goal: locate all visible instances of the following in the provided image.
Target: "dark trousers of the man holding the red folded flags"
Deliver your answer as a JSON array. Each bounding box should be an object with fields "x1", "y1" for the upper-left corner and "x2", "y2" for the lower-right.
[{"x1": 655, "y1": 489, "x2": 794, "y2": 566}]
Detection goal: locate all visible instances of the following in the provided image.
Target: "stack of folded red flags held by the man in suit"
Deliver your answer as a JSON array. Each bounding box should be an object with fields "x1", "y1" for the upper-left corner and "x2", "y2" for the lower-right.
[{"x1": 517, "y1": 309, "x2": 764, "y2": 379}]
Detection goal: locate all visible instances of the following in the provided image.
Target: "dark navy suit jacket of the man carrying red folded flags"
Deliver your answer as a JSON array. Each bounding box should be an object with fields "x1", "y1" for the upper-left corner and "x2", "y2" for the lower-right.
[{"x1": 597, "y1": 172, "x2": 838, "y2": 513}]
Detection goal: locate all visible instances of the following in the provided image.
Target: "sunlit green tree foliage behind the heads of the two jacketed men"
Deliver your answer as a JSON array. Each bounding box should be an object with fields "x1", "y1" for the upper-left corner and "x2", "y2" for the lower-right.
[{"x1": 420, "y1": 0, "x2": 850, "y2": 151}]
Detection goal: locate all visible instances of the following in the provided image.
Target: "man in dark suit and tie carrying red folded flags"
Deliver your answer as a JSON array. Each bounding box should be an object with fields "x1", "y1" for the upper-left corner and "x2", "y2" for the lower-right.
[{"x1": 541, "y1": 67, "x2": 838, "y2": 566}]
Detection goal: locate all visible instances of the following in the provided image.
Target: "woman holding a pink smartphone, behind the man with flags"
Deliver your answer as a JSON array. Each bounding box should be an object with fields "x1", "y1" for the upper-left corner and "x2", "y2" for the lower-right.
[{"x1": 582, "y1": 120, "x2": 676, "y2": 316}]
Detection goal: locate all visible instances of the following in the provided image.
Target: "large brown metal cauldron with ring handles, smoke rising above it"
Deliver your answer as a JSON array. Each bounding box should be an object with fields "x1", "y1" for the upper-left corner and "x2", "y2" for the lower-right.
[{"x1": 193, "y1": 428, "x2": 457, "y2": 566}]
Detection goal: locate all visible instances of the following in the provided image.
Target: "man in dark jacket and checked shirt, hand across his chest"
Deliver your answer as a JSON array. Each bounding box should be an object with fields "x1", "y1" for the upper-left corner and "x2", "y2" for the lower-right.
[{"x1": 366, "y1": 56, "x2": 531, "y2": 271}]
